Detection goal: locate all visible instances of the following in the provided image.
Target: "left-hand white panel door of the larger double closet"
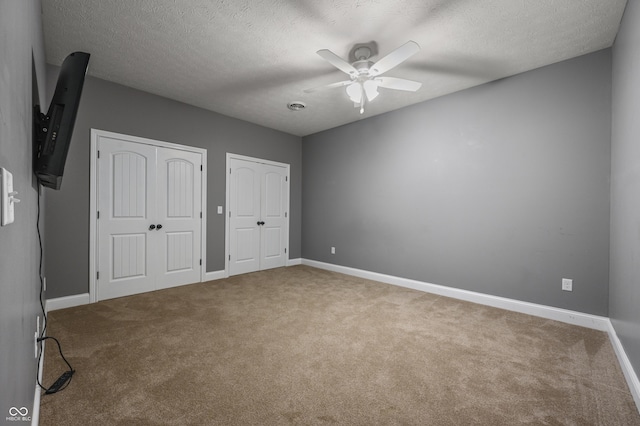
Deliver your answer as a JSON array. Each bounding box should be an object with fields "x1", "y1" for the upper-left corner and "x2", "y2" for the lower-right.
[{"x1": 97, "y1": 138, "x2": 156, "y2": 300}]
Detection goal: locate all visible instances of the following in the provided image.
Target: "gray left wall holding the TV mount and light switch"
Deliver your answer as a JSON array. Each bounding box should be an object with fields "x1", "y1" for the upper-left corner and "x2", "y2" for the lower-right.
[{"x1": 0, "y1": 0, "x2": 45, "y2": 424}]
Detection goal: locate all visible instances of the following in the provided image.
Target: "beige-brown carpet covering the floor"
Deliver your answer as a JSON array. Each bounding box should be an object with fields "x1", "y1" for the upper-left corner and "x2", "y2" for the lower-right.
[{"x1": 40, "y1": 266, "x2": 640, "y2": 425}]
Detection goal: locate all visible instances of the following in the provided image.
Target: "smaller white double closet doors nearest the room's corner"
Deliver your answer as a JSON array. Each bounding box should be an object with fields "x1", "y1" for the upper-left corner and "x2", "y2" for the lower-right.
[{"x1": 227, "y1": 155, "x2": 289, "y2": 275}]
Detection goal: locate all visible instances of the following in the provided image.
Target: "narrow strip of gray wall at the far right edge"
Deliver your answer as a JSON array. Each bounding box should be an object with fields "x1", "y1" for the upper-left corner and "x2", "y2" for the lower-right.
[{"x1": 609, "y1": 1, "x2": 640, "y2": 373}]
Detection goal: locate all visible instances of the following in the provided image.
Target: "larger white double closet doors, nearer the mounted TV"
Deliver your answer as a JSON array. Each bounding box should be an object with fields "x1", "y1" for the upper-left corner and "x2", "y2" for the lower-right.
[{"x1": 96, "y1": 136, "x2": 203, "y2": 300}]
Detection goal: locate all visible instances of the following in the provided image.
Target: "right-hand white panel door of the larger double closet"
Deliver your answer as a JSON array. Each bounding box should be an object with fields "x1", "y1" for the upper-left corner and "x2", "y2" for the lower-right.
[{"x1": 155, "y1": 148, "x2": 202, "y2": 288}]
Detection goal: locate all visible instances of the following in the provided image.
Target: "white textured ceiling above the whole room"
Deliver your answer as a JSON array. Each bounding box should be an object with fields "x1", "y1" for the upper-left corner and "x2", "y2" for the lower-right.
[{"x1": 42, "y1": 0, "x2": 627, "y2": 136}]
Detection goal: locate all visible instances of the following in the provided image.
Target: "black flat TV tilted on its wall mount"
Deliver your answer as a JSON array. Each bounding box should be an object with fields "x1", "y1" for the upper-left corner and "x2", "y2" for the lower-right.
[{"x1": 34, "y1": 52, "x2": 90, "y2": 189}]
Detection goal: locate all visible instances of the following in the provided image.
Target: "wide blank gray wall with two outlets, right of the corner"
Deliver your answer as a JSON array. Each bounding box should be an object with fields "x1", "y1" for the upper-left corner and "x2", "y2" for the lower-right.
[{"x1": 302, "y1": 50, "x2": 611, "y2": 315}]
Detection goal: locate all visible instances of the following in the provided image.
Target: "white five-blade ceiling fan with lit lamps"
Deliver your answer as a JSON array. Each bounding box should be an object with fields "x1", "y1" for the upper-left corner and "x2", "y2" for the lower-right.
[{"x1": 305, "y1": 41, "x2": 422, "y2": 114}]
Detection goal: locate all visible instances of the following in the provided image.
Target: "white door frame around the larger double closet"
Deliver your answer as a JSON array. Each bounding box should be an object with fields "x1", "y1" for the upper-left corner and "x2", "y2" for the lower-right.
[{"x1": 89, "y1": 128, "x2": 207, "y2": 303}]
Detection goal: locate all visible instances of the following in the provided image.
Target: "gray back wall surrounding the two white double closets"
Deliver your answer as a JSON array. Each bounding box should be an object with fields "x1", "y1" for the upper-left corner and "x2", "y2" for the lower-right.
[{"x1": 45, "y1": 73, "x2": 302, "y2": 298}]
